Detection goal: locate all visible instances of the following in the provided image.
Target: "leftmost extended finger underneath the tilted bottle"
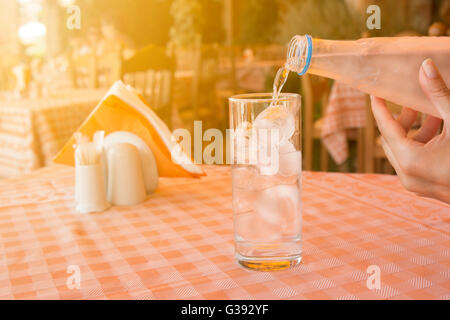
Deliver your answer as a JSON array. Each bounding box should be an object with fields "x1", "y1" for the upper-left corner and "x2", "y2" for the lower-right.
[{"x1": 370, "y1": 96, "x2": 407, "y2": 155}]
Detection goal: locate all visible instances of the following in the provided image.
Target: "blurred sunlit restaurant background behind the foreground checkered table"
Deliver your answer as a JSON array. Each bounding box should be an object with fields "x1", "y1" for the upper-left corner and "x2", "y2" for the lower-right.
[{"x1": 0, "y1": 0, "x2": 450, "y2": 177}]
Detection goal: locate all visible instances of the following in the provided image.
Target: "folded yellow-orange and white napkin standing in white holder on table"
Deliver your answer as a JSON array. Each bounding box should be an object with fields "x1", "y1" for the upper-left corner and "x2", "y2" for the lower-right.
[{"x1": 53, "y1": 81, "x2": 204, "y2": 177}]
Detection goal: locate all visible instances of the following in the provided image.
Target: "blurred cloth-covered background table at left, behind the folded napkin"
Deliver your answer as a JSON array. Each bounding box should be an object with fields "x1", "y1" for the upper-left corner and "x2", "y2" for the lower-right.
[{"x1": 0, "y1": 89, "x2": 106, "y2": 177}]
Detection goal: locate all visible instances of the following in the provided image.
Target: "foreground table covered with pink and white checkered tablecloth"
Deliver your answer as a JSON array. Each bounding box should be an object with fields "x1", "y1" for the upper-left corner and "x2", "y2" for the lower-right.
[{"x1": 0, "y1": 166, "x2": 450, "y2": 300}]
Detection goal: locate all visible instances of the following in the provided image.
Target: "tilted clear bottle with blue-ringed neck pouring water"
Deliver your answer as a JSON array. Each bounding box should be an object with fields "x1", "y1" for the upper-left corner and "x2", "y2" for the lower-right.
[{"x1": 286, "y1": 35, "x2": 450, "y2": 116}]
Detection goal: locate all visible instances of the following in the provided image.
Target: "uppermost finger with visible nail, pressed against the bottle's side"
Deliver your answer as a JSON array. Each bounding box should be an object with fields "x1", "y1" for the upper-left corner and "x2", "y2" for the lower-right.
[{"x1": 419, "y1": 59, "x2": 450, "y2": 122}]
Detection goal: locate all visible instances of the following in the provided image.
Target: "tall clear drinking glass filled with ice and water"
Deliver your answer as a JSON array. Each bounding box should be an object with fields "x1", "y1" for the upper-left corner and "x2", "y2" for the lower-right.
[{"x1": 229, "y1": 93, "x2": 302, "y2": 271}]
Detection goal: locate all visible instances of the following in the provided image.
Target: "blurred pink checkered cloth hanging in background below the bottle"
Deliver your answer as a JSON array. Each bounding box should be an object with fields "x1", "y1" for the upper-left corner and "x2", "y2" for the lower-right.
[{"x1": 321, "y1": 81, "x2": 367, "y2": 164}]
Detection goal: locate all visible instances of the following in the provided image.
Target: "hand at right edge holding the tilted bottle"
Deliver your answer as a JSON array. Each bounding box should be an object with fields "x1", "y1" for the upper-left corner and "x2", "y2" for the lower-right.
[{"x1": 371, "y1": 59, "x2": 450, "y2": 204}]
